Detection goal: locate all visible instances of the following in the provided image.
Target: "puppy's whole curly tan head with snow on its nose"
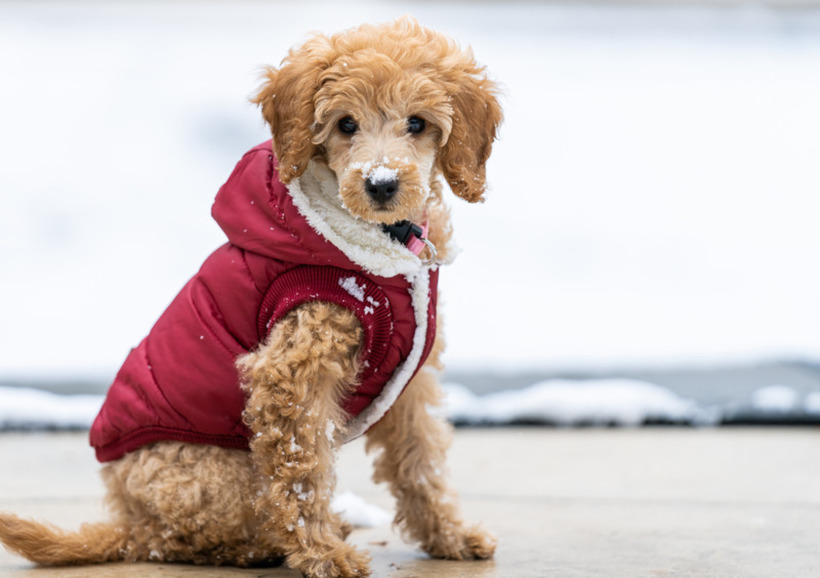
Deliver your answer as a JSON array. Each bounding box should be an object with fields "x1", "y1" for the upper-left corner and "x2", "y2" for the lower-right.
[{"x1": 253, "y1": 18, "x2": 501, "y2": 223}]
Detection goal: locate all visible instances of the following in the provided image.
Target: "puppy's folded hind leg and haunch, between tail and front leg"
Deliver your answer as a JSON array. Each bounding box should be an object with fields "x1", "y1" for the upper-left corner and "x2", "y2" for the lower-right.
[{"x1": 102, "y1": 442, "x2": 281, "y2": 566}]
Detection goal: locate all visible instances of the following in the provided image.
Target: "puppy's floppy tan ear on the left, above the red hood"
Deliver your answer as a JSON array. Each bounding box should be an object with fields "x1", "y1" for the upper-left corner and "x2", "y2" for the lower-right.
[{"x1": 251, "y1": 37, "x2": 330, "y2": 184}]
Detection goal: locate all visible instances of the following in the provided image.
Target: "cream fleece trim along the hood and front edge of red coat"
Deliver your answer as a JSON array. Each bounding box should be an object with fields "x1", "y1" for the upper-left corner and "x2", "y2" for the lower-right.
[{"x1": 288, "y1": 162, "x2": 430, "y2": 443}]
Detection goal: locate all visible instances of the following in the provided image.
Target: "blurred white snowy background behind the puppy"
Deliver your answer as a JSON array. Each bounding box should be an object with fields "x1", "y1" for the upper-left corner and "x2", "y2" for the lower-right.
[{"x1": 0, "y1": 0, "x2": 820, "y2": 423}]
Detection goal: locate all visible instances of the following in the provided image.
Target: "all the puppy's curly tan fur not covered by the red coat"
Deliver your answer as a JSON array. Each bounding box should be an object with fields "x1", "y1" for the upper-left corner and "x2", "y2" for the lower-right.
[{"x1": 0, "y1": 18, "x2": 501, "y2": 578}]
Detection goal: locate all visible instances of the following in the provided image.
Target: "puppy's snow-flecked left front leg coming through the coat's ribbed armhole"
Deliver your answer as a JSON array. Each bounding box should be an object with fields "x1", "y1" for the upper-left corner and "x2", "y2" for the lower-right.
[{"x1": 239, "y1": 303, "x2": 370, "y2": 577}]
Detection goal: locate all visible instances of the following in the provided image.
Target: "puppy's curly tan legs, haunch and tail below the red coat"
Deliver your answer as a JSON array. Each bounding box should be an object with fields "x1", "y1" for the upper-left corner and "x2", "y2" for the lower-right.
[{"x1": 0, "y1": 303, "x2": 495, "y2": 578}]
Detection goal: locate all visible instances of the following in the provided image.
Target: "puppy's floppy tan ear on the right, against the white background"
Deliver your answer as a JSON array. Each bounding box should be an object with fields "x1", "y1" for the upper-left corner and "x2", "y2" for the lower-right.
[{"x1": 439, "y1": 65, "x2": 502, "y2": 203}]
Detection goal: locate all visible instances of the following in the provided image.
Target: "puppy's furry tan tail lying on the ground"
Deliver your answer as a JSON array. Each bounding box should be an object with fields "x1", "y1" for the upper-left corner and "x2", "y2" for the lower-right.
[{"x1": 0, "y1": 513, "x2": 128, "y2": 566}]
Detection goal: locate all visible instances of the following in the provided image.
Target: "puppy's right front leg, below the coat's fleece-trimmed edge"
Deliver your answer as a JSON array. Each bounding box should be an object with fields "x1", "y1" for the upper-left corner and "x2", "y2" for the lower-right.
[{"x1": 366, "y1": 332, "x2": 496, "y2": 560}]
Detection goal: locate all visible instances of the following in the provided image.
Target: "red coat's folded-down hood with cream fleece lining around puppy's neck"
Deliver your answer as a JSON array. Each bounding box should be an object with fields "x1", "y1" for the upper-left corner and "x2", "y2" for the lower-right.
[{"x1": 212, "y1": 141, "x2": 426, "y2": 283}]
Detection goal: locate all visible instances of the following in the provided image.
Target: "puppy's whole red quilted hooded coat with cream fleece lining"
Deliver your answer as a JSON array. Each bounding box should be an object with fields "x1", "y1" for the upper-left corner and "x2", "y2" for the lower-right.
[{"x1": 91, "y1": 141, "x2": 438, "y2": 462}]
